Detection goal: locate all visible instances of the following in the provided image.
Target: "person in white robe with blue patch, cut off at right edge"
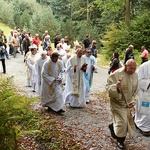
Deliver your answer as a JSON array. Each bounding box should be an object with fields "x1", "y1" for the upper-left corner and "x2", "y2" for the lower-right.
[{"x1": 134, "y1": 61, "x2": 150, "y2": 136}]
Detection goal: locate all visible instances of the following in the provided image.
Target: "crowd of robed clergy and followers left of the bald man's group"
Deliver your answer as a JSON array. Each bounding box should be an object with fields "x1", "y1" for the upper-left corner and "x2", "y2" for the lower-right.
[{"x1": 1, "y1": 28, "x2": 97, "y2": 110}]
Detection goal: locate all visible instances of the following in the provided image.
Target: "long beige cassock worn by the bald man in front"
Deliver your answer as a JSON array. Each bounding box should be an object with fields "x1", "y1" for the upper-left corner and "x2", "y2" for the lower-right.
[{"x1": 106, "y1": 67, "x2": 138, "y2": 137}]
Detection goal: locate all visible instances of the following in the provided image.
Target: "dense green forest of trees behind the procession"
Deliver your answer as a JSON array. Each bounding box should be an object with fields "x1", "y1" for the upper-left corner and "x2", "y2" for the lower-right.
[{"x1": 0, "y1": 0, "x2": 150, "y2": 57}]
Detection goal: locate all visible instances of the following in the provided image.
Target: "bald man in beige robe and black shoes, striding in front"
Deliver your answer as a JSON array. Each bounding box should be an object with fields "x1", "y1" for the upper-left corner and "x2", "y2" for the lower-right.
[{"x1": 106, "y1": 59, "x2": 138, "y2": 149}]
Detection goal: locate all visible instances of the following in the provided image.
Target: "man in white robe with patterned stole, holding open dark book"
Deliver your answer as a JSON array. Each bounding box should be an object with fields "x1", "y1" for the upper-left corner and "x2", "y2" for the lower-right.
[{"x1": 63, "y1": 48, "x2": 87, "y2": 107}]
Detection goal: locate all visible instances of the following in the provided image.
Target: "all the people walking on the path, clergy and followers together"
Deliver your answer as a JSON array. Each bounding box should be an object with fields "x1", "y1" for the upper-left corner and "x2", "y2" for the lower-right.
[{"x1": 0, "y1": 29, "x2": 150, "y2": 149}]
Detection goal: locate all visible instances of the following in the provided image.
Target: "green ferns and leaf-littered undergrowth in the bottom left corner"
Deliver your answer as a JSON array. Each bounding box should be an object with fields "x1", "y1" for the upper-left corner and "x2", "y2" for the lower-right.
[{"x1": 0, "y1": 76, "x2": 83, "y2": 150}]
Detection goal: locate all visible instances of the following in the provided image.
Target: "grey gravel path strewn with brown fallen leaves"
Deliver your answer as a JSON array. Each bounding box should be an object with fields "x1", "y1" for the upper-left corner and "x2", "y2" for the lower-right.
[{"x1": 0, "y1": 54, "x2": 150, "y2": 150}]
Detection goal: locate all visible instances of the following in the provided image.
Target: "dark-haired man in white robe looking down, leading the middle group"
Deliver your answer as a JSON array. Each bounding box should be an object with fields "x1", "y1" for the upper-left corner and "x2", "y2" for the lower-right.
[{"x1": 41, "y1": 52, "x2": 65, "y2": 112}]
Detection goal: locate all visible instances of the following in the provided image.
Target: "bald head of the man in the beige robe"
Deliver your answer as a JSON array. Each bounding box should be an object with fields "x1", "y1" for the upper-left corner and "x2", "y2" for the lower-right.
[{"x1": 125, "y1": 59, "x2": 136, "y2": 75}]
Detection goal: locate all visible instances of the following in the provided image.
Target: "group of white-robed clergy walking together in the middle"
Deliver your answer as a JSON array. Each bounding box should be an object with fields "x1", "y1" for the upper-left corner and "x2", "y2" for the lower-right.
[{"x1": 25, "y1": 37, "x2": 96, "y2": 113}]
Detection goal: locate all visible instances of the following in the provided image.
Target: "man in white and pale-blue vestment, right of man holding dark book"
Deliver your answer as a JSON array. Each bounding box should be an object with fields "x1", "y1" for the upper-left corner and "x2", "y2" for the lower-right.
[{"x1": 83, "y1": 49, "x2": 96, "y2": 103}]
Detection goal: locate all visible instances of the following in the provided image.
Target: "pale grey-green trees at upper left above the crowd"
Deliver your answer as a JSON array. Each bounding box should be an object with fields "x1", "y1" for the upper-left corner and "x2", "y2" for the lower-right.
[{"x1": 0, "y1": 0, "x2": 60, "y2": 37}]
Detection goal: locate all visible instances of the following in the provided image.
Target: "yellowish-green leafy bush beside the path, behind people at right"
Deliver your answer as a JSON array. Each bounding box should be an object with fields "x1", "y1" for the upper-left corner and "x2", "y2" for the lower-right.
[{"x1": 101, "y1": 23, "x2": 130, "y2": 60}]
